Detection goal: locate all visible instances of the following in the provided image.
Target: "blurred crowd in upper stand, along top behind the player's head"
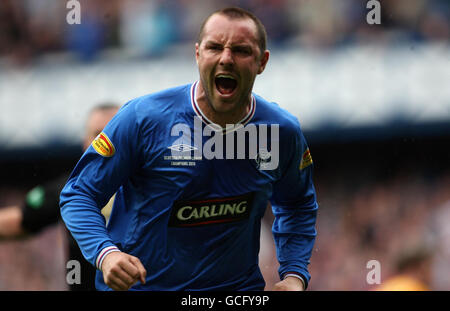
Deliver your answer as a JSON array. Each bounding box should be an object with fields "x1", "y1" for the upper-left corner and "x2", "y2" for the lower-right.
[{"x1": 0, "y1": 0, "x2": 450, "y2": 64}]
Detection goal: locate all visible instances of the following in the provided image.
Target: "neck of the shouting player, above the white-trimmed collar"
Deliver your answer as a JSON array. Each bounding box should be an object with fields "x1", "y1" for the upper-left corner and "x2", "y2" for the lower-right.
[{"x1": 195, "y1": 81, "x2": 252, "y2": 128}]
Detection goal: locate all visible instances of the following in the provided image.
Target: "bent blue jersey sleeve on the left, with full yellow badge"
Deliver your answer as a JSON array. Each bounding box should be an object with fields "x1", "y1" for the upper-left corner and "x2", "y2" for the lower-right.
[{"x1": 60, "y1": 103, "x2": 140, "y2": 268}]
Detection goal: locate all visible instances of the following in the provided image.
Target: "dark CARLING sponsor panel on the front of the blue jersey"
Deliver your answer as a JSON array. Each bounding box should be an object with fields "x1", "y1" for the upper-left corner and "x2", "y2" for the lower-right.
[{"x1": 169, "y1": 192, "x2": 253, "y2": 227}]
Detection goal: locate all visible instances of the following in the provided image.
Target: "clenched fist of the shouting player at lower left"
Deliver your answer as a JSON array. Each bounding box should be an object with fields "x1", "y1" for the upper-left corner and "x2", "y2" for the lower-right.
[{"x1": 101, "y1": 252, "x2": 147, "y2": 290}]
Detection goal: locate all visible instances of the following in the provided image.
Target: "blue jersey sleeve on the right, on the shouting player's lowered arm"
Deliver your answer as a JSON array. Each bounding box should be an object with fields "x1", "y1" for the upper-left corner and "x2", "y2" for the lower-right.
[{"x1": 271, "y1": 122, "x2": 318, "y2": 288}]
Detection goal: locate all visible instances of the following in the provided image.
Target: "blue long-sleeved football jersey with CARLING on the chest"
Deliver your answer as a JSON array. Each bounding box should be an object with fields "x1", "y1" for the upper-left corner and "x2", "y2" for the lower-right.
[{"x1": 60, "y1": 82, "x2": 318, "y2": 290}]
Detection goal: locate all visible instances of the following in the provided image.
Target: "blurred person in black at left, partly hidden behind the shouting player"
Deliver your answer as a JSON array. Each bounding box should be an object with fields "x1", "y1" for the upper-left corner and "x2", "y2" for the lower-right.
[{"x1": 0, "y1": 103, "x2": 119, "y2": 291}]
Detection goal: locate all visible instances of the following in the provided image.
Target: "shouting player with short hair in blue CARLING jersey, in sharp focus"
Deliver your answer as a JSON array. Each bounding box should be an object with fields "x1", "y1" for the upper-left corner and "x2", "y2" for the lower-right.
[{"x1": 61, "y1": 8, "x2": 318, "y2": 290}]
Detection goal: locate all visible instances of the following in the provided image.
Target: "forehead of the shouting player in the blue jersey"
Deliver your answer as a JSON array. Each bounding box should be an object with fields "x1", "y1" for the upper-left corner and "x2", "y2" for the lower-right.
[{"x1": 202, "y1": 14, "x2": 258, "y2": 44}]
